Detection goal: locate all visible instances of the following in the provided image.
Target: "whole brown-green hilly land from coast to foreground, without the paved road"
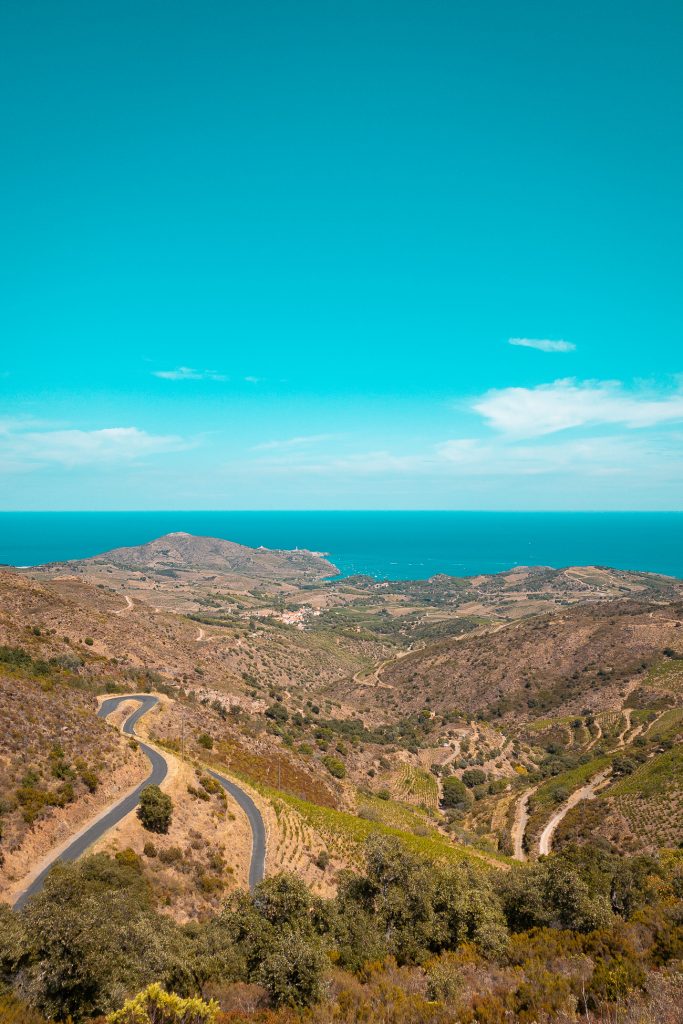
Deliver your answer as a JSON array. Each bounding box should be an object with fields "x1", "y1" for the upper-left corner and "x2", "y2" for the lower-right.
[{"x1": 0, "y1": 538, "x2": 683, "y2": 1024}]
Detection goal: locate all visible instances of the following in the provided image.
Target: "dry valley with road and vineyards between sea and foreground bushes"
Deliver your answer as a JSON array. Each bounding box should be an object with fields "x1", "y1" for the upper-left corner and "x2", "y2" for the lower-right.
[{"x1": 0, "y1": 535, "x2": 683, "y2": 1019}]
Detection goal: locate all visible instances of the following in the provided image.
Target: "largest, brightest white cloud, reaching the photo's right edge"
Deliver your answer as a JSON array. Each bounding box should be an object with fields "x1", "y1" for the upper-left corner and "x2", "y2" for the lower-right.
[{"x1": 472, "y1": 379, "x2": 683, "y2": 437}]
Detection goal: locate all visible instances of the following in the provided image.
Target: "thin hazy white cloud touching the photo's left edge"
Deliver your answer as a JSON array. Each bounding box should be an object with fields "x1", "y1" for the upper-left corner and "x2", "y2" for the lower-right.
[{"x1": 0, "y1": 427, "x2": 190, "y2": 466}]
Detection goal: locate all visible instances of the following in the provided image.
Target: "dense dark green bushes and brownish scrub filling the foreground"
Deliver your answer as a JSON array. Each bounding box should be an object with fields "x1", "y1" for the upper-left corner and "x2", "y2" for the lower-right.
[{"x1": 0, "y1": 838, "x2": 683, "y2": 1024}]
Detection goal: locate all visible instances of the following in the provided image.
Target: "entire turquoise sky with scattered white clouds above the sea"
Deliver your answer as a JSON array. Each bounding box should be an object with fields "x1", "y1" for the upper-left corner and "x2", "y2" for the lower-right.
[{"x1": 0, "y1": 0, "x2": 683, "y2": 510}]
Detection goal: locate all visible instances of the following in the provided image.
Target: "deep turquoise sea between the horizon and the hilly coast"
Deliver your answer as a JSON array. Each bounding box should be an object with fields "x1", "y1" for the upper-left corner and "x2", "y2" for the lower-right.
[{"x1": 0, "y1": 512, "x2": 683, "y2": 580}]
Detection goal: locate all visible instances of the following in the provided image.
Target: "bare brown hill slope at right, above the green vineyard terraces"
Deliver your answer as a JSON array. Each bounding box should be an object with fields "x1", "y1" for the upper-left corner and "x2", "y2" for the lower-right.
[{"x1": 380, "y1": 600, "x2": 683, "y2": 718}]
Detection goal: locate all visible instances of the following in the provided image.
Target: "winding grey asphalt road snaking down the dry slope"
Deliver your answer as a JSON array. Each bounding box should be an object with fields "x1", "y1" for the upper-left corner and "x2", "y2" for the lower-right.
[{"x1": 14, "y1": 693, "x2": 265, "y2": 910}]
